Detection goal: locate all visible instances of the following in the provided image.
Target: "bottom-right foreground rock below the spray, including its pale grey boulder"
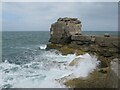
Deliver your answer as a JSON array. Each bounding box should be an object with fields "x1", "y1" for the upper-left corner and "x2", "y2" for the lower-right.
[{"x1": 64, "y1": 60, "x2": 120, "y2": 88}]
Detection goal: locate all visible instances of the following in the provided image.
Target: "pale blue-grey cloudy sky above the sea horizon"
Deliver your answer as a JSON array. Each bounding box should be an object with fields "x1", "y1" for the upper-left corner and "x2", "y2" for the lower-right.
[{"x1": 2, "y1": 2, "x2": 118, "y2": 31}]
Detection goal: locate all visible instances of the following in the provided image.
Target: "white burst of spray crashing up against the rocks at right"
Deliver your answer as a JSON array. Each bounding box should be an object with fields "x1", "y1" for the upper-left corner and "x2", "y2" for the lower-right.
[{"x1": 73, "y1": 53, "x2": 100, "y2": 78}]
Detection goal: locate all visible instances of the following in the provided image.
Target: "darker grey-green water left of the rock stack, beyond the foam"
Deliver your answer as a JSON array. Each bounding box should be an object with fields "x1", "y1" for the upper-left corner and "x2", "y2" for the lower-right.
[{"x1": 2, "y1": 31, "x2": 49, "y2": 64}]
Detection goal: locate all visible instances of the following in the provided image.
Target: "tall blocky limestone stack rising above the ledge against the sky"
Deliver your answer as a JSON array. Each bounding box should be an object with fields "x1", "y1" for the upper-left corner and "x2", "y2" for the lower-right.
[{"x1": 49, "y1": 17, "x2": 82, "y2": 44}]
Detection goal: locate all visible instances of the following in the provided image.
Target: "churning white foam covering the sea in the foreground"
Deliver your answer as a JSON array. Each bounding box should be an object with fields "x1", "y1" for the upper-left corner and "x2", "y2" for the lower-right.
[{"x1": 0, "y1": 51, "x2": 99, "y2": 88}]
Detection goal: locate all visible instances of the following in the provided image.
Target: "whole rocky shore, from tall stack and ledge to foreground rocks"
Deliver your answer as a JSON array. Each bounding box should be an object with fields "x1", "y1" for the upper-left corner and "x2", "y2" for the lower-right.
[{"x1": 47, "y1": 17, "x2": 120, "y2": 88}]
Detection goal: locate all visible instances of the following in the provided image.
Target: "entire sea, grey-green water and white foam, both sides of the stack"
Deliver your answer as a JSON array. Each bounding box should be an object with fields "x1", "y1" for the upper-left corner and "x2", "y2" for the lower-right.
[{"x1": 0, "y1": 31, "x2": 118, "y2": 89}]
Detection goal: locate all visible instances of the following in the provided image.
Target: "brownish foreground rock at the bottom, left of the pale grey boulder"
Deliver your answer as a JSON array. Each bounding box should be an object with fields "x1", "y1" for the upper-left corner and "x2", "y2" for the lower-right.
[{"x1": 64, "y1": 70, "x2": 110, "y2": 89}]
